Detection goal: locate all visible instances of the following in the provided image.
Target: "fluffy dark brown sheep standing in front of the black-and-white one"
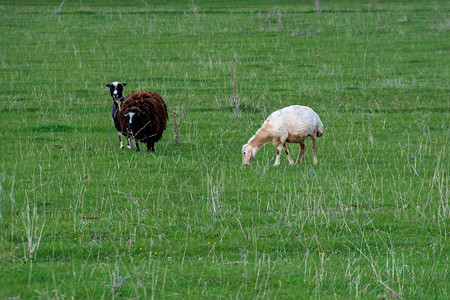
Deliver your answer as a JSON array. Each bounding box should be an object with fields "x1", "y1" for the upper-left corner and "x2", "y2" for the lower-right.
[{"x1": 118, "y1": 91, "x2": 169, "y2": 152}]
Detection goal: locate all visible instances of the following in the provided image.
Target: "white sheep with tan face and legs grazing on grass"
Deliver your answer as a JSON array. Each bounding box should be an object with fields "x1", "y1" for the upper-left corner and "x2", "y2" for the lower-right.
[{"x1": 242, "y1": 105, "x2": 323, "y2": 166}]
